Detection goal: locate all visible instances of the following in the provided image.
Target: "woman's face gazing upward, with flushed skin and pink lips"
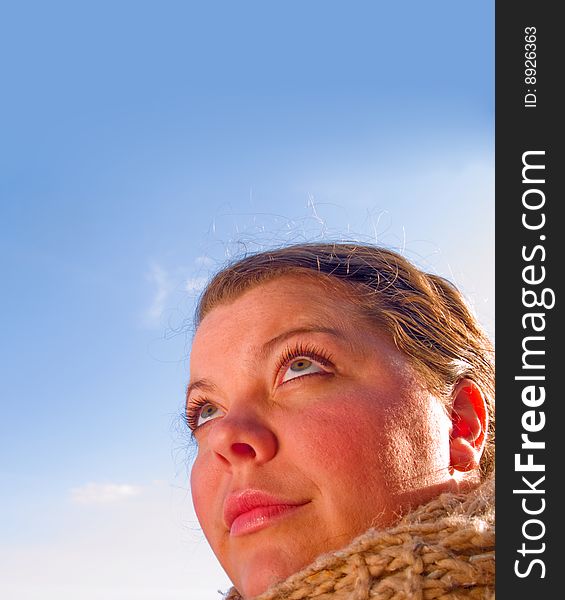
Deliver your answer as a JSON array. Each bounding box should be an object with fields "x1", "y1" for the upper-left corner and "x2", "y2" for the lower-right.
[{"x1": 187, "y1": 275, "x2": 450, "y2": 598}]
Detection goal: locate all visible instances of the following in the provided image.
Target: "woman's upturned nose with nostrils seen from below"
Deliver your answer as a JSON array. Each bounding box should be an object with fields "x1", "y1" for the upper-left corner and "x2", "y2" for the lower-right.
[{"x1": 208, "y1": 411, "x2": 278, "y2": 466}]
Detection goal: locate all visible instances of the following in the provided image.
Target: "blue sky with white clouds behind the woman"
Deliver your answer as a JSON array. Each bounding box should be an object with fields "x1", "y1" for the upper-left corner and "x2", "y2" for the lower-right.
[{"x1": 0, "y1": 0, "x2": 494, "y2": 600}]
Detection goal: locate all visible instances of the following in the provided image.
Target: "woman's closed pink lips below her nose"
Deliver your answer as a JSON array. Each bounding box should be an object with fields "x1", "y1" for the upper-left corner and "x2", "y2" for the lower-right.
[{"x1": 224, "y1": 490, "x2": 307, "y2": 536}]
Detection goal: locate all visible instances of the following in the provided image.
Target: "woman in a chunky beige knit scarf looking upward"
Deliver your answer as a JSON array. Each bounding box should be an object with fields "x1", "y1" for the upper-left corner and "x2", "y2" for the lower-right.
[{"x1": 187, "y1": 244, "x2": 494, "y2": 600}]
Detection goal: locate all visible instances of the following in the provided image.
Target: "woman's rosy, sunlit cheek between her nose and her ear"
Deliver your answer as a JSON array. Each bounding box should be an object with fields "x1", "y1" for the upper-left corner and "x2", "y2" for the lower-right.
[{"x1": 286, "y1": 392, "x2": 449, "y2": 492}]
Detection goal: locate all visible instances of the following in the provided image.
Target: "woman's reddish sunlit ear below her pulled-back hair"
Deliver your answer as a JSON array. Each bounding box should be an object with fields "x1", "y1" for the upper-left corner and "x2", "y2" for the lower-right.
[{"x1": 449, "y1": 379, "x2": 488, "y2": 471}]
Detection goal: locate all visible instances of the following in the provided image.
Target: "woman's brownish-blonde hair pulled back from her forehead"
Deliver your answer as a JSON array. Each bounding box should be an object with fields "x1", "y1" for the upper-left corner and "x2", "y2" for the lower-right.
[{"x1": 196, "y1": 243, "x2": 494, "y2": 477}]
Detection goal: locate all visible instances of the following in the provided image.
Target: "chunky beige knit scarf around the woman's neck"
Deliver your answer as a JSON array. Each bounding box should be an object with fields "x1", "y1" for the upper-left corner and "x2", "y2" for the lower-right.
[{"x1": 226, "y1": 478, "x2": 494, "y2": 600}]
